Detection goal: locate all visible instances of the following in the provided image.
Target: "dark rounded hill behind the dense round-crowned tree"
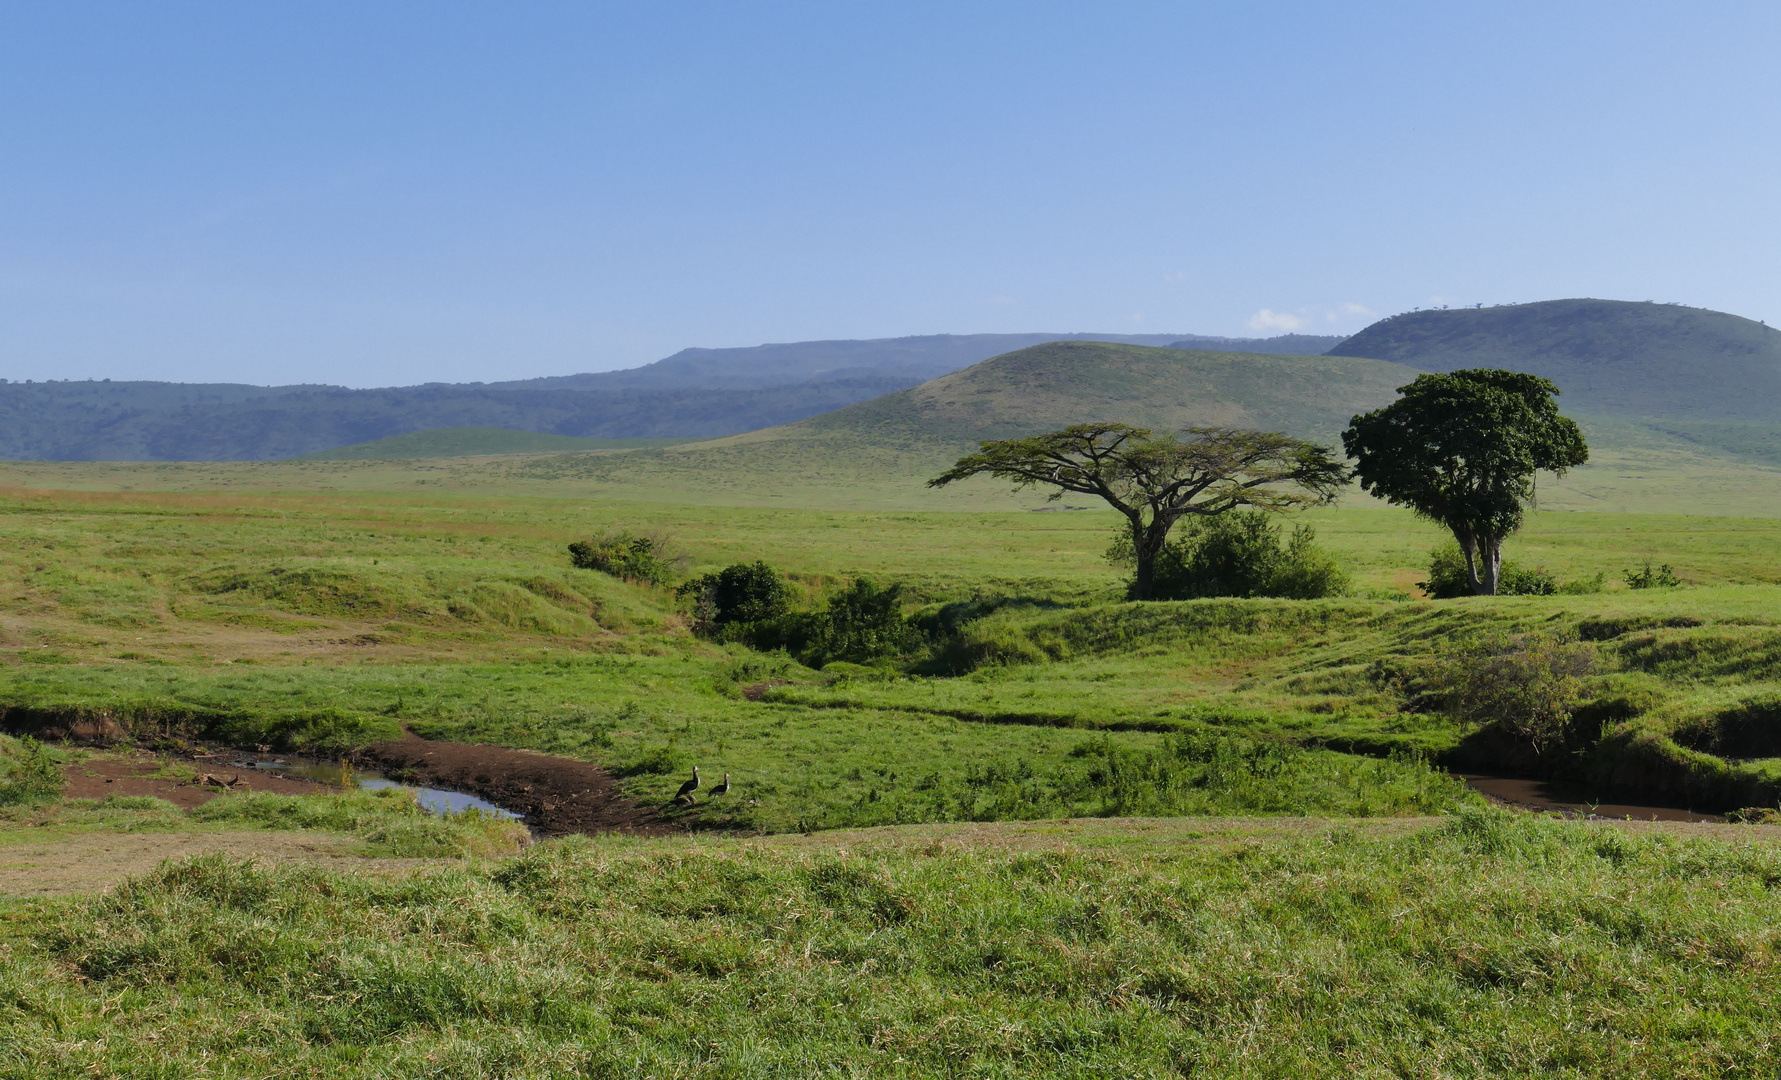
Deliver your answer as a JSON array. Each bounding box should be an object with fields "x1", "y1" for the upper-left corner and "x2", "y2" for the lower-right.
[{"x1": 1330, "y1": 299, "x2": 1781, "y2": 427}]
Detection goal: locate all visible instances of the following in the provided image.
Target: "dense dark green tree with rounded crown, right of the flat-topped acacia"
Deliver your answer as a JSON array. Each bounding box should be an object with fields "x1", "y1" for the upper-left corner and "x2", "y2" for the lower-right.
[{"x1": 1341, "y1": 367, "x2": 1589, "y2": 595}]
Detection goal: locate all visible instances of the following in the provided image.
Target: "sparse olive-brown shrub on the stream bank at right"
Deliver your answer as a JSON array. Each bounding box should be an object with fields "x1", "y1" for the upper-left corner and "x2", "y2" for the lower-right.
[{"x1": 1434, "y1": 631, "x2": 1596, "y2": 757}]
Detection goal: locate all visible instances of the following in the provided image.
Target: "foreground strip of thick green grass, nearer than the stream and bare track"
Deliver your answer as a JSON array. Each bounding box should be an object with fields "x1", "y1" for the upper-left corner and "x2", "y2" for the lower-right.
[{"x1": 0, "y1": 809, "x2": 1781, "y2": 1078}]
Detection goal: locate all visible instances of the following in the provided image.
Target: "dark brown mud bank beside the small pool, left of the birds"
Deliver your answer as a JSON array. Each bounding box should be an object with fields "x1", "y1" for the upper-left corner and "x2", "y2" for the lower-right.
[{"x1": 358, "y1": 736, "x2": 686, "y2": 836}]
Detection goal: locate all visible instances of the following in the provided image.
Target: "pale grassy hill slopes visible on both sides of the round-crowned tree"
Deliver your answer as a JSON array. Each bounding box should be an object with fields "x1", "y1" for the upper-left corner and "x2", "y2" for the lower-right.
[{"x1": 470, "y1": 342, "x2": 1781, "y2": 510}]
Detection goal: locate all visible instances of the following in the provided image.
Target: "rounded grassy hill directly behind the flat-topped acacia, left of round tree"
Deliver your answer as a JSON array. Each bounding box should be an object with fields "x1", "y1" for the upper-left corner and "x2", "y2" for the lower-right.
[{"x1": 495, "y1": 342, "x2": 1416, "y2": 504}]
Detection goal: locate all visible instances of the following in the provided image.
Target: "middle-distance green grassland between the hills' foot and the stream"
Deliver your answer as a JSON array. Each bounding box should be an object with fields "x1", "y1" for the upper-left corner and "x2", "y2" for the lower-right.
[{"x1": 0, "y1": 481, "x2": 1781, "y2": 819}]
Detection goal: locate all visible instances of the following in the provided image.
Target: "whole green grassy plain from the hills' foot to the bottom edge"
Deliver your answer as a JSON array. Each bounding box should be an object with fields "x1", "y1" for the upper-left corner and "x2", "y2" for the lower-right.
[{"x1": 0, "y1": 449, "x2": 1781, "y2": 1076}]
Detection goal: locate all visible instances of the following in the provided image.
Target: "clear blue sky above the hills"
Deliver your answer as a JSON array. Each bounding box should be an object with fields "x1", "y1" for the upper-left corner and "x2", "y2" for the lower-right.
[{"x1": 0, "y1": 0, "x2": 1781, "y2": 387}]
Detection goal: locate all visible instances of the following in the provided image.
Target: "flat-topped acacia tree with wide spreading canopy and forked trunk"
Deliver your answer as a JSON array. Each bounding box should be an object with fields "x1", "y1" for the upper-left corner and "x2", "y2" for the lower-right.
[{"x1": 928, "y1": 424, "x2": 1348, "y2": 601}]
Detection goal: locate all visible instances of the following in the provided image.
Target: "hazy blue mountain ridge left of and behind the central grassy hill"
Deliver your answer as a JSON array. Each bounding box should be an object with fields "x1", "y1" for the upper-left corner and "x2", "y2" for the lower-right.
[{"x1": 0, "y1": 333, "x2": 1339, "y2": 462}]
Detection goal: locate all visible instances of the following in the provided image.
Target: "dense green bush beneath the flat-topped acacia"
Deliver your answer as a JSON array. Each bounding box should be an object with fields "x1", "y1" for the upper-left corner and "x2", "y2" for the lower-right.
[{"x1": 1108, "y1": 510, "x2": 1348, "y2": 601}]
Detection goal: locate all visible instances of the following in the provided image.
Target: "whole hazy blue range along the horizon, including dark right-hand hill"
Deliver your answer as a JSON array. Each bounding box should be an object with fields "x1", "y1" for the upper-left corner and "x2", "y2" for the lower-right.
[{"x1": 0, "y1": 299, "x2": 1781, "y2": 463}]
